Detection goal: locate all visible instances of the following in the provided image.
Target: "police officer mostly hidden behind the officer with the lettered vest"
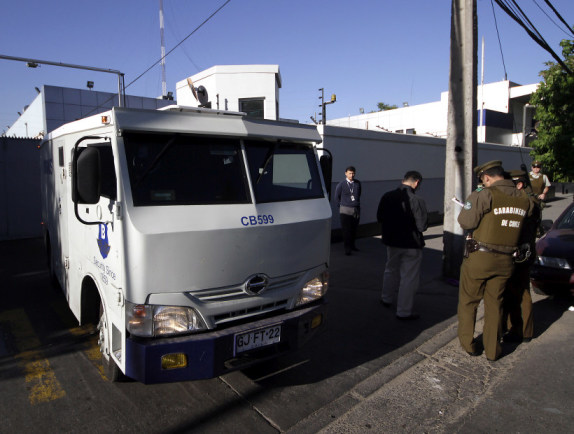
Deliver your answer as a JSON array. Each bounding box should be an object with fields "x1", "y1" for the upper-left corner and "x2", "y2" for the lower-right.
[{"x1": 502, "y1": 170, "x2": 541, "y2": 342}]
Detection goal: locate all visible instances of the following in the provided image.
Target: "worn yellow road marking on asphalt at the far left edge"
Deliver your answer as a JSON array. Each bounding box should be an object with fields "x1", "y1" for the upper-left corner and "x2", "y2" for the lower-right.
[{"x1": 0, "y1": 309, "x2": 66, "y2": 405}]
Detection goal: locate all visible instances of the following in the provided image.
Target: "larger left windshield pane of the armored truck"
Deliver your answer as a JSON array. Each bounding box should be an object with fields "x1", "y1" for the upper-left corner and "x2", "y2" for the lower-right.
[{"x1": 124, "y1": 132, "x2": 250, "y2": 206}]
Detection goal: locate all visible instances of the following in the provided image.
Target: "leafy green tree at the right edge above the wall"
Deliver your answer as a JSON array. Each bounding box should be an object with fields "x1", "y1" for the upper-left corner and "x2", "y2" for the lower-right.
[{"x1": 530, "y1": 35, "x2": 574, "y2": 182}]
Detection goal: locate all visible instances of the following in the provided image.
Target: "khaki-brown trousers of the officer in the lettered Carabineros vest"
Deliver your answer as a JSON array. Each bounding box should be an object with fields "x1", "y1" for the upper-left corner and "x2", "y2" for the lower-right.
[{"x1": 458, "y1": 251, "x2": 514, "y2": 360}]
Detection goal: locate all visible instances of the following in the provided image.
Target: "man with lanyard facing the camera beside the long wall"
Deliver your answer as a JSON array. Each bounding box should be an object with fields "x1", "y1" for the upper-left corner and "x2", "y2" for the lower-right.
[{"x1": 335, "y1": 166, "x2": 361, "y2": 256}]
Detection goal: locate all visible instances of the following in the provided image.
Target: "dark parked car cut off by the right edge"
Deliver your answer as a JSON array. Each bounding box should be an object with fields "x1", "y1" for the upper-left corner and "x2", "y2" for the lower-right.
[{"x1": 530, "y1": 202, "x2": 574, "y2": 294}]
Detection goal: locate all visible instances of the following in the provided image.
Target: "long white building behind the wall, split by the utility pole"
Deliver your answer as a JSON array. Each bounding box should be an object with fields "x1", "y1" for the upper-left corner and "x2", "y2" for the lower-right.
[{"x1": 327, "y1": 81, "x2": 538, "y2": 146}]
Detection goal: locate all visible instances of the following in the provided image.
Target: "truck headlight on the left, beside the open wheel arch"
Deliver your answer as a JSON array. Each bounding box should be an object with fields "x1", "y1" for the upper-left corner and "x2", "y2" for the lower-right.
[{"x1": 126, "y1": 302, "x2": 207, "y2": 337}]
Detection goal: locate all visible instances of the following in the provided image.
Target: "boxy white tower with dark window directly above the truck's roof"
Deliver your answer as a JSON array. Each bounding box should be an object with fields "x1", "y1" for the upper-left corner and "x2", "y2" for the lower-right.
[{"x1": 176, "y1": 65, "x2": 281, "y2": 120}]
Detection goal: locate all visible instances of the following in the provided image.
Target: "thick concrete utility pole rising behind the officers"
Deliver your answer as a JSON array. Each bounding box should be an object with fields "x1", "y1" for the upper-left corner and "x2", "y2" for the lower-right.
[{"x1": 443, "y1": 0, "x2": 477, "y2": 279}]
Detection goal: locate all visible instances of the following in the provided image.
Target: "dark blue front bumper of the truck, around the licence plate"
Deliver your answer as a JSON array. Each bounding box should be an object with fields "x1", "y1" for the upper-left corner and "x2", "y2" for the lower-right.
[{"x1": 125, "y1": 302, "x2": 326, "y2": 384}]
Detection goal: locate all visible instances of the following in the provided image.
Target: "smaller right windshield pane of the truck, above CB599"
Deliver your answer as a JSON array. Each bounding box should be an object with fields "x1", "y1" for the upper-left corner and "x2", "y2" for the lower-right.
[{"x1": 245, "y1": 140, "x2": 324, "y2": 203}]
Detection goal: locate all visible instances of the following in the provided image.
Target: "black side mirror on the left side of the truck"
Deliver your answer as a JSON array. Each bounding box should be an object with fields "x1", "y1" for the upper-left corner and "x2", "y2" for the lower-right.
[{"x1": 73, "y1": 147, "x2": 101, "y2": 204}]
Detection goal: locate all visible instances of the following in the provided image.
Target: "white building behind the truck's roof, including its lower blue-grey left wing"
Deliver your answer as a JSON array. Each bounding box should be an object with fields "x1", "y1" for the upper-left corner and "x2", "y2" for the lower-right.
[{"x1": 5, "y1": 65, "x2": 281, "y2": 138}]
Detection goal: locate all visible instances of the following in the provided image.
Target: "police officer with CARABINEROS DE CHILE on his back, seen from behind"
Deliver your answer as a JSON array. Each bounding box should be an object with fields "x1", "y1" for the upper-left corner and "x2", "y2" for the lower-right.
[{"x1": 458, "y1": 161, "x2": 532, "y2": 361}]
